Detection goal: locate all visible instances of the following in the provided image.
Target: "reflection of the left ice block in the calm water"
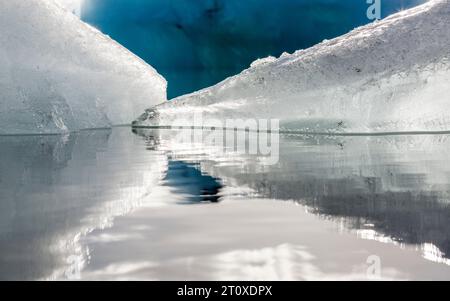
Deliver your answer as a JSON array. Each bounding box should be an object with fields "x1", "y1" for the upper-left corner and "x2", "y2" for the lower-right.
[{"x1": 0, "y1": 129, "x2": 167, "y2": 279}]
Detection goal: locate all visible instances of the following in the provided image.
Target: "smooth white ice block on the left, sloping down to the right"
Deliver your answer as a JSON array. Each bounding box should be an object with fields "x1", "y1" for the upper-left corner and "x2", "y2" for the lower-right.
[{"x1": 0, "y1": 0, "x2": 166, "y2": 134}]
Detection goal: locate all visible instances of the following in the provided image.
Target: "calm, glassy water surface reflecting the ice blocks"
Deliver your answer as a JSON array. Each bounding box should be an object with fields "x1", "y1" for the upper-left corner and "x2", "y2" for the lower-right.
[{"x1": 0, "y1": 128, "x2": 450, "y2": 280}]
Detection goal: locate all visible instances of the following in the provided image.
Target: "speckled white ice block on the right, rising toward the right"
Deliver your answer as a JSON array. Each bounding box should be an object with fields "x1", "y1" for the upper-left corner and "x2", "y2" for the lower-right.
[{"x1": 134, "y1": 0, "x2": 450, "y2": 133}]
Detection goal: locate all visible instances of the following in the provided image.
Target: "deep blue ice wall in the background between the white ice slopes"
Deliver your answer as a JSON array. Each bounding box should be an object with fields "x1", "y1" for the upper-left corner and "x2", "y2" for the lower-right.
[{"x1": 81, "y1": 0, "x2": 424, "y2": 97}]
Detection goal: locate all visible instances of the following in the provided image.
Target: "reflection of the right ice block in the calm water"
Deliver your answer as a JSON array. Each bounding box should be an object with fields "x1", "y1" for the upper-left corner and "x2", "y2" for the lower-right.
[{"x1": 135, "y1": 130, "x2": 450, "y2": 263}]
